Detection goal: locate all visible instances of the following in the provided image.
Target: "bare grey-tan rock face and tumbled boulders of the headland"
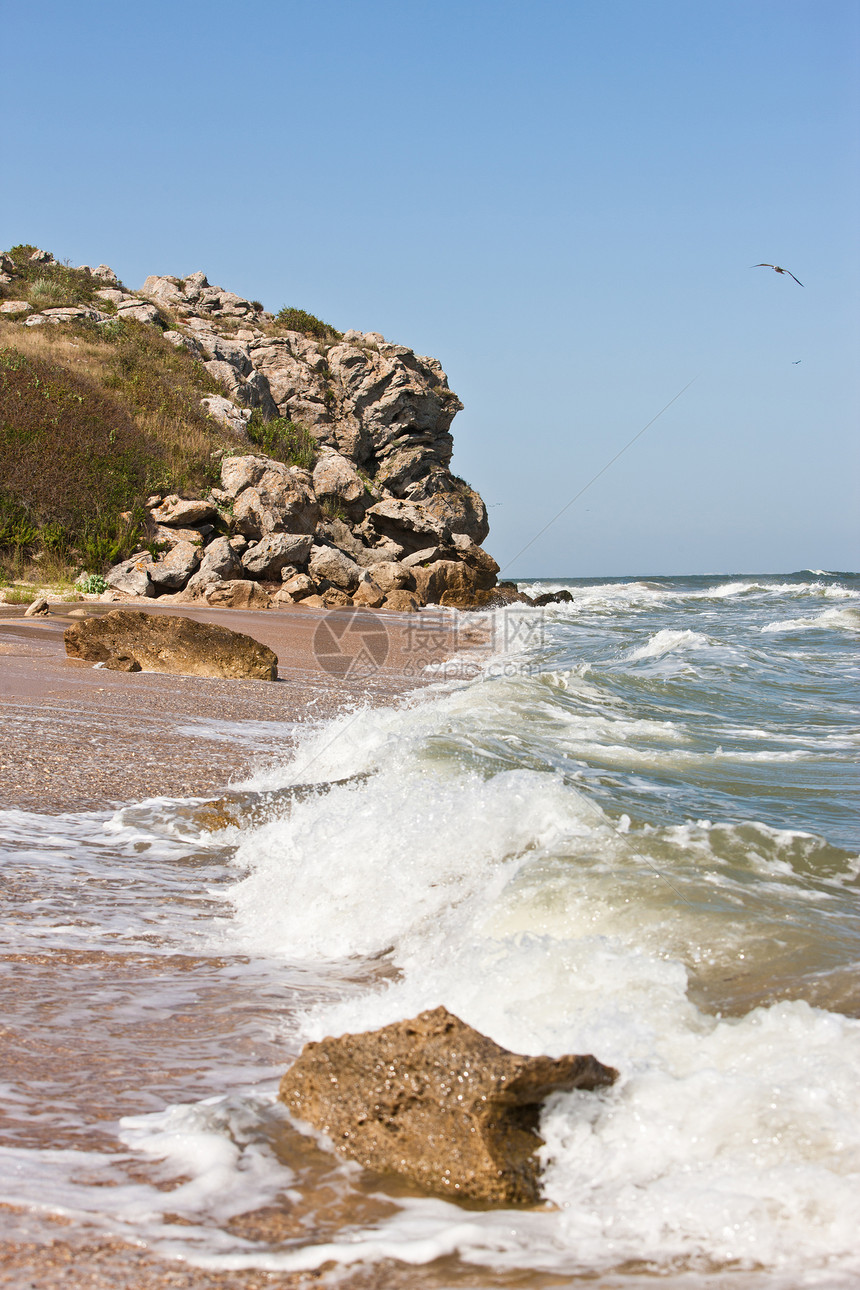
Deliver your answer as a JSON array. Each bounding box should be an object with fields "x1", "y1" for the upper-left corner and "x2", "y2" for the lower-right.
[{"x1": 0, "y1": 249, "x2": 508, "y2": 609}]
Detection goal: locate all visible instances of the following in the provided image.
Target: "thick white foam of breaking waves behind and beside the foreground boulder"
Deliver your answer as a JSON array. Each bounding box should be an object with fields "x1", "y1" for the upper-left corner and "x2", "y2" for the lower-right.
[{"x1": 141, "y1": 686, "x2": 860, "y2": 1275}]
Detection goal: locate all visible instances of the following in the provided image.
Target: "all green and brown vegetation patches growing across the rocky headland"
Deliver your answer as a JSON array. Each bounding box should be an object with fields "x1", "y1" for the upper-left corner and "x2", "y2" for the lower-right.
[{"x1": 0, "y1": 244, "x2": 340, "y2": 585}]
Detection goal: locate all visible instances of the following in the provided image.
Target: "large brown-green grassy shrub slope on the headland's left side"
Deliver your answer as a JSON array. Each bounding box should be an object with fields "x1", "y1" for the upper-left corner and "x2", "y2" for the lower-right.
[{"x1": 0, "y1": 321, "x2": 235, "y2": 577}]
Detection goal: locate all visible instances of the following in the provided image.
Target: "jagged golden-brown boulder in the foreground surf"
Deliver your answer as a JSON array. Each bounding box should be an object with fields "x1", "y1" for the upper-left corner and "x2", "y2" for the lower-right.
[{"x1": 279, "y1": 1007, "x2": 618, "y2": 1206}]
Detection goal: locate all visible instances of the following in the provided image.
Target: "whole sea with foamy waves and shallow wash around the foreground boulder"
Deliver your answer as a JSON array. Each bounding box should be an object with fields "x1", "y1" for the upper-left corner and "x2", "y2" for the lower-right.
[{"x1": 0, "y1": 569, "x2": 860, "y2": 1290}]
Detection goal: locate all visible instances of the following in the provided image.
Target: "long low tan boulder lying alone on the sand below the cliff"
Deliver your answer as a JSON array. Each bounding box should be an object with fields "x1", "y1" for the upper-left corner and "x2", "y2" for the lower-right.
[{"x1": 63, "y1": 608, "x2": 277, "y2": 681}]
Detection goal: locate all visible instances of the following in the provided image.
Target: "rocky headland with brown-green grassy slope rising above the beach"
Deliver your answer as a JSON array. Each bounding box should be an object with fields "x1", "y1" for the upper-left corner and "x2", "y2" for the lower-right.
[{"x1": 0, "y1": 245, "x2": 498, "y2": 608}]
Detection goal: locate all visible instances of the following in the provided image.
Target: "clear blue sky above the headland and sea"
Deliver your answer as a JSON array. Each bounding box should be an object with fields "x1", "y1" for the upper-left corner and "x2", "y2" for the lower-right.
[{"x1": 0, "y1": 0, "x2": 860, "y2": 577}]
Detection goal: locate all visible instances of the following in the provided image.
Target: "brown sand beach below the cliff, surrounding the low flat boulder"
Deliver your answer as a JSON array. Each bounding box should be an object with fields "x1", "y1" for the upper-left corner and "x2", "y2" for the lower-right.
[{"x1": 0, "y1": 600, "x2": 471, "y2": 813}]
